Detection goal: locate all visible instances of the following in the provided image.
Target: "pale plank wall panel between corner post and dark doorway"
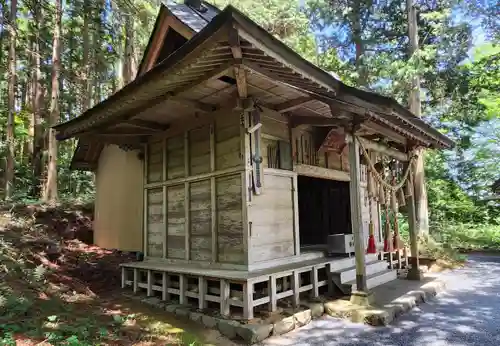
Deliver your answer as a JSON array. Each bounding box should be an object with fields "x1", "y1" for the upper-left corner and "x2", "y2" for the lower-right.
[{"x1": 249, "y1": 172, "x2": 295, "y2": 263}]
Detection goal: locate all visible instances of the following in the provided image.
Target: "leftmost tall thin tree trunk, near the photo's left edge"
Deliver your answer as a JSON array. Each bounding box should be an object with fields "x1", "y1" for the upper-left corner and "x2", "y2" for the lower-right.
[{"x1": 5, "y1": 0, "x2": 17, "y2": 199}]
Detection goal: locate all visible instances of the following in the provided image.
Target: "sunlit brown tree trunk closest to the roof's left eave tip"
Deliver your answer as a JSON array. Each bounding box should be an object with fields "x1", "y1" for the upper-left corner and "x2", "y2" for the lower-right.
[{"x1": 43, "y1": 0, "x2": 62, "y2": 203}]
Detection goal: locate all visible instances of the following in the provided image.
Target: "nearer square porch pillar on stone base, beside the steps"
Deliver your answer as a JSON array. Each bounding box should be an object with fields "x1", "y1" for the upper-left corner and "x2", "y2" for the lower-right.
[{"x1": 348, "y1": 136, "x2": 371, "y2": 305}]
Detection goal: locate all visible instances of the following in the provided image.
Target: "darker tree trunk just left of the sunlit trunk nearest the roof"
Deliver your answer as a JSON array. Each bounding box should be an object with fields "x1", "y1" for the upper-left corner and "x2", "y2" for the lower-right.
[{"x1": 31, "y1": 2, "x2": 43, "y2": 197}]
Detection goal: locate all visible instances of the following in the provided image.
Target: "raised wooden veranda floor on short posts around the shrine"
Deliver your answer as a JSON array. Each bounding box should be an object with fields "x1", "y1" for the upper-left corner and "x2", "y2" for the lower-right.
[{"x1": 122, "y1": 251, "x2": 392, "y2": 319}]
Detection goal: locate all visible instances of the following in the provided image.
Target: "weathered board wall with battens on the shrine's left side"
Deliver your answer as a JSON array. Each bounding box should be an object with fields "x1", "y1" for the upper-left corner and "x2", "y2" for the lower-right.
[{"x1": 144, "y1": 111, "x2": 246, "y2": 265}]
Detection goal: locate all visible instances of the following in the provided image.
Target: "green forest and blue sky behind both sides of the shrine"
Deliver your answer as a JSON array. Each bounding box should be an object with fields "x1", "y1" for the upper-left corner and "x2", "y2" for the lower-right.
[{"x1": 0, "y1": 0, "x2": 500, "y2": 248}]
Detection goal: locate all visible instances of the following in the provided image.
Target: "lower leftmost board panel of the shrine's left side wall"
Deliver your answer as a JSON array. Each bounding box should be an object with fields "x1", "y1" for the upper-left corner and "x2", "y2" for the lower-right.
[{"x1": 146, "y1": 188, "x2": 165, "y2": 257}]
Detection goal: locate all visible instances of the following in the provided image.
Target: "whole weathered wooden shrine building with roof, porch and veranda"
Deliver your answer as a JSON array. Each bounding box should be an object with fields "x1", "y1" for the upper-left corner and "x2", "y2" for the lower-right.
[{"x1": 56, "y1": 1, "x2": 453, "y2": 319}]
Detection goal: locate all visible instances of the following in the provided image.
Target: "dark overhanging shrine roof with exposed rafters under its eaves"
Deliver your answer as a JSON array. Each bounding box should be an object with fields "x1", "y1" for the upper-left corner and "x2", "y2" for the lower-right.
[{"x1": 61, "y1": 0, "x2": 453, "y2": 170}]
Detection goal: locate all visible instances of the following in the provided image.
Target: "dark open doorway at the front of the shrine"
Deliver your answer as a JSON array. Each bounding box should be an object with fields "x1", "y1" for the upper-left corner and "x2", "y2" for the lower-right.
[{"x1": 298, "y1": 176, "x2": 352, "y2": 246}]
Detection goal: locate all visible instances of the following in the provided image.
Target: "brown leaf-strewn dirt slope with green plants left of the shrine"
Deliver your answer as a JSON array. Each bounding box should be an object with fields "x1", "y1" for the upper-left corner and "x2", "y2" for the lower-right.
[{"x1": 0, "y1": 205, "x2": 233, "y2": 345}]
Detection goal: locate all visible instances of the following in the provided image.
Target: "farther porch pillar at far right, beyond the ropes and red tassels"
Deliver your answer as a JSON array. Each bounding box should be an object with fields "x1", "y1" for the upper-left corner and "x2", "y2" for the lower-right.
[{"x1": 406, "y1": 167, "x2": 422, "y2": 280}]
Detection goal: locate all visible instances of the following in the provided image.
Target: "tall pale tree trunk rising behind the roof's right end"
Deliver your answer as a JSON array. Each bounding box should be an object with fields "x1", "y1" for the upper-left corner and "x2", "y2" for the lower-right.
[{"x1": 406, "y1": 0, "x2": 429, "y2": 235}]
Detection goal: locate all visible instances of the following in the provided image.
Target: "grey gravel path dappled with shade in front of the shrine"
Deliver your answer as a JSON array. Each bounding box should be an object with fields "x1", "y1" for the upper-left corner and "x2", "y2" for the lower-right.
[{"x1": 263, "y1": 255, "x2": 500, "y2": 346}]
